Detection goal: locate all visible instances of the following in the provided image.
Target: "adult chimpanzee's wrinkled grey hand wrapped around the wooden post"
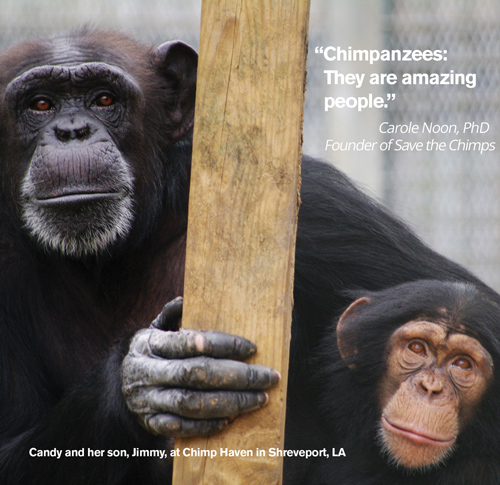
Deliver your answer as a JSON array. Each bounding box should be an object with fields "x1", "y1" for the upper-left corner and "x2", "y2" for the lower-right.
[{"x1": 122, "y1": 298, "x2": 279, "y2": 436}]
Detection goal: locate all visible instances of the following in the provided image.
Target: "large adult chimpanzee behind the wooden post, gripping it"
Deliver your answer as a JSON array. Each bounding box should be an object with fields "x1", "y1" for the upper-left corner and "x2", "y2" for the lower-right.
[{"x1": 0, "y1": 30, "x2": 498, "y2": 484}]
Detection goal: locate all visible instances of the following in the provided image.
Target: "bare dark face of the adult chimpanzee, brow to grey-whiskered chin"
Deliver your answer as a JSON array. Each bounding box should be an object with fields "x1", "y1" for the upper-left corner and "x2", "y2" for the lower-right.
[{"x1": 6, "y1": 62, "x2": 141, "y2": 256}]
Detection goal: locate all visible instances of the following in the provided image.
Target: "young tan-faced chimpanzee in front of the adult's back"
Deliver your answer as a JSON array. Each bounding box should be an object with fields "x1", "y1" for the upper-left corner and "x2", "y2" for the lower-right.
[{"x1": 292, "y1": 280, "x2": 500, "y2": 485}]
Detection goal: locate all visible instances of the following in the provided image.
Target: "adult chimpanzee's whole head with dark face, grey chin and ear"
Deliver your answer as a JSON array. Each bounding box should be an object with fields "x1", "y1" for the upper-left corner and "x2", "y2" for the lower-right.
[{"x1": 2, "y1": 31, "x2": 196, "y2": 257}]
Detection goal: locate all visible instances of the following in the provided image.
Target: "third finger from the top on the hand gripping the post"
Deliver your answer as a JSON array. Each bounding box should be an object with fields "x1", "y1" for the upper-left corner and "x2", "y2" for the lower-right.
[{"x1": 127, "y1": 387, "x2": 268, "y2": 419}]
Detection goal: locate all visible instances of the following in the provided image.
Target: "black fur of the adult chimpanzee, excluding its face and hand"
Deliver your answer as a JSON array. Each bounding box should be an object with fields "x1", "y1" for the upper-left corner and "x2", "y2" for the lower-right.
[{"x1": 0, "y1": 32, "x2": 498, "y2": 484}]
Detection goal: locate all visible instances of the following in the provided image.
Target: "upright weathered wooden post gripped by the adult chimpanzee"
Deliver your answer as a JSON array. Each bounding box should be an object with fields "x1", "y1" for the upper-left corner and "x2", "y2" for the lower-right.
[{"x1": 174, "y1": 0, "x2": 309, "y2": 485}]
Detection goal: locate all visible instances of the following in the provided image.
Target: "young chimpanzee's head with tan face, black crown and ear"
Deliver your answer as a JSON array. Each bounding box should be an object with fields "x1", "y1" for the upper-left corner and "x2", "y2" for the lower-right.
[{"x1": 337, "y1": 281, "x2": 497, "y2": 471}]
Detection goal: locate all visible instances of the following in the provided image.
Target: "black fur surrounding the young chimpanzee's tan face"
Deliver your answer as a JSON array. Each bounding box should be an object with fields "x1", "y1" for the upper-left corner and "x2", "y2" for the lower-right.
[{"x1": 288, "y1": 280, "x2": 500, "y2": 485}]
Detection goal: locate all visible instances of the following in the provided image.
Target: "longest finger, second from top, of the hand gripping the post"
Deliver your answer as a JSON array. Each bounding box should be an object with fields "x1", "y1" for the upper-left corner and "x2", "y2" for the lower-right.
[{"x1": 127, "y1": 357, "x2": 280, "y2": 391}]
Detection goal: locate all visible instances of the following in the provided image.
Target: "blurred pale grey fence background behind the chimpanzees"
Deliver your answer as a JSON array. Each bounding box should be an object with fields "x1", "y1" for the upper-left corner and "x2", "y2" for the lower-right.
[{"x1": 0, "y1": 0, "x2": 500, "y2": 291}]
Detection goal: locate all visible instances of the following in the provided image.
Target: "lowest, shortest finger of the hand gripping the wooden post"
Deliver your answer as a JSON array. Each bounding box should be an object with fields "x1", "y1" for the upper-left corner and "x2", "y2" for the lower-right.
[{"x1": 141, "y1": 414, "x2": 228, "y2": 437}]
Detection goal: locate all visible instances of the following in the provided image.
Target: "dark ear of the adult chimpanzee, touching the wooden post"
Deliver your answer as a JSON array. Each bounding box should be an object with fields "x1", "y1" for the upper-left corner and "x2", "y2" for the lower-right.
[{"x1": 152, "y1": 41, "x2": 198, "y2": 143}]
